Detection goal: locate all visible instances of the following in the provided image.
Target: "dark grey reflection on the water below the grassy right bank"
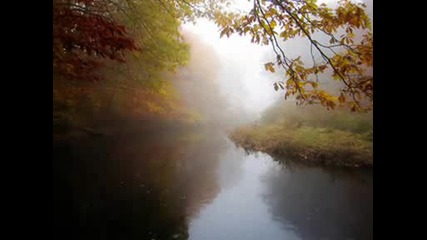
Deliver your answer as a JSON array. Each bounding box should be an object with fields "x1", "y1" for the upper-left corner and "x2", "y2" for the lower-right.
[{"x1": 263, "y1": 158, "x2": 373, "y2": 240}]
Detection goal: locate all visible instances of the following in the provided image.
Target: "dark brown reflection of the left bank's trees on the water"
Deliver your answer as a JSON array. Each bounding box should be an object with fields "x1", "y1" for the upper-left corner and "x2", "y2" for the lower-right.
[{"x1": 54, "y1": 131, "x2": 224, "y2": 239}]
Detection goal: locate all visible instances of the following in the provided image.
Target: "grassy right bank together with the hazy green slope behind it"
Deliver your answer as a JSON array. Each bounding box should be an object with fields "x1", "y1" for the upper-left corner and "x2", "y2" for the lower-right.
[{"x1": 229, "y1": 104, "x2": 373, "y2": 167}]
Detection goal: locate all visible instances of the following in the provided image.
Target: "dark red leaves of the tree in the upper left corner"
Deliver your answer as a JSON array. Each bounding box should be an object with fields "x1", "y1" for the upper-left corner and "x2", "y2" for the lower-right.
[{"x1": 53, "y1": 0, "x2": 136, "y2": 80}]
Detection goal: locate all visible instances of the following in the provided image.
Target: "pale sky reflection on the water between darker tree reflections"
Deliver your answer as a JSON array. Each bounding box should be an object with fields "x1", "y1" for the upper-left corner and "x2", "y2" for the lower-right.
[{"x1": 189, "y1": 148, "x2": 298, "y2": 240}]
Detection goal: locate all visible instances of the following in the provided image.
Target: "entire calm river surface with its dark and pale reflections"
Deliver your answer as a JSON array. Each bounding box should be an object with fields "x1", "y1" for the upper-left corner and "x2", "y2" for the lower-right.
[{"x1": 53, "y1": 130, "x2": 373, "y2": 240}]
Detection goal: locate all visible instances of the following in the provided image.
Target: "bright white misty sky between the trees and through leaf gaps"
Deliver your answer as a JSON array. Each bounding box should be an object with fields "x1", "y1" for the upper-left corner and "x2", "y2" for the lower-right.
[{"x1": 183, "y1": 0, "x2": 373, "y2": 120}]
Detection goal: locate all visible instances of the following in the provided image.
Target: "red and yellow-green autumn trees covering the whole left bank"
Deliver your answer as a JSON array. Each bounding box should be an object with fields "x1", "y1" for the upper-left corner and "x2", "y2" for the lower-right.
[{"x1": 53, "y1": 0, "x2": 214, "y2": 135}]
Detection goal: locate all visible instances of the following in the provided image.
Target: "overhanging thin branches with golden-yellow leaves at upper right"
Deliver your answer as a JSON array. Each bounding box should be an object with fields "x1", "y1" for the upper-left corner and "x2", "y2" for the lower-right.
[{"x1": 214, "y1": 0, "x2": 373, "y2": 111}]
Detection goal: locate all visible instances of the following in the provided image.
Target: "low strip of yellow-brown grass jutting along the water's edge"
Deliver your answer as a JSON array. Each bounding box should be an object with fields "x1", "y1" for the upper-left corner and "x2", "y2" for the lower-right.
[{"x1": 229, "y1": 124, "x2": 373, "y2": 167}]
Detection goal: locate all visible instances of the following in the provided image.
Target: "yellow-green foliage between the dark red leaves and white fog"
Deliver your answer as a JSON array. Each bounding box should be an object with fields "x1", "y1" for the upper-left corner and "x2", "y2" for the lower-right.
[{"x1": 111, "y1": 0, "x2": 190, "y2": 90}]
